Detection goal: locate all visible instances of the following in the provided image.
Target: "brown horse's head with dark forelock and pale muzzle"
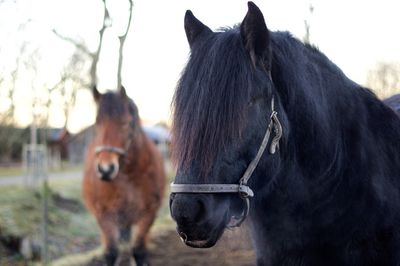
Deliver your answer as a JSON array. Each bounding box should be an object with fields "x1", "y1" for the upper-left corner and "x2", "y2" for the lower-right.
[{"x1": 93, "y1": 86, "x2": 139, "y2": 181}]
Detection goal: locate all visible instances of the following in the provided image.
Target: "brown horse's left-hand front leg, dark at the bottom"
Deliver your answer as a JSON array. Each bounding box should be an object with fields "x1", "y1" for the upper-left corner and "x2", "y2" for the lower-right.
[{"x1": 98, "y1": 219, "x2": 119, "y2": 266}]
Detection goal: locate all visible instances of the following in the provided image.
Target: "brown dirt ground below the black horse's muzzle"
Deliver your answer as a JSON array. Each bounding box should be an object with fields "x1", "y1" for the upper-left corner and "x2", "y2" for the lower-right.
[{"x1": 85, "y1": 229, "x2": 255, "y2": 266}]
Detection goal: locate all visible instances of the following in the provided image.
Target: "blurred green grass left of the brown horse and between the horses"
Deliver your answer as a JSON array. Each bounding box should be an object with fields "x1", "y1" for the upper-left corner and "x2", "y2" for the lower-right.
[{"x1": 0, "y1": 162, "x2": 174, "y2": 266}]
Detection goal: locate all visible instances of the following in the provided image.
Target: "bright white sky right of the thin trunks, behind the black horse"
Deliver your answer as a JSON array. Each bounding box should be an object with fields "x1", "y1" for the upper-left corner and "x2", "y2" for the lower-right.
[{"x1": 124, "y1": 0, "x2": 400, "y2": 127}]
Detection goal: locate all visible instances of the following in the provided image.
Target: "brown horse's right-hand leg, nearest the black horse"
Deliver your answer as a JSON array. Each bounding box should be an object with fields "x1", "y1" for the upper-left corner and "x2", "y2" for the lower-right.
[{"x1": 132, "y1": 212, "x2": 156, "y2": 266}]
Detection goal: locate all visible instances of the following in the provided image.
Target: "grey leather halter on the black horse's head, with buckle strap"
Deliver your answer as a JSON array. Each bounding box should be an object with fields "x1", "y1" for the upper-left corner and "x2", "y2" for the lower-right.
[{"x1": 171, "y1": 97, "x2": 282, "y2": 227}]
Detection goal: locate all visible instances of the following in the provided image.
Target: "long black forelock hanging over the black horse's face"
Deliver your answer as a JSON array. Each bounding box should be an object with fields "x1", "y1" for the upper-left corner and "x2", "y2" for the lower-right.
[{"x1": 172, "y1": 28, "x2": 253, "y2": 175}]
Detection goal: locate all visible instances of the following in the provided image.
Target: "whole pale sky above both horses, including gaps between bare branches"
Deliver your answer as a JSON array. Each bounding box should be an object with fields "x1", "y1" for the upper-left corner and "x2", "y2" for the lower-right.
[{"x1": 0, "y1": 0, "x2": 400, "y2": 131}]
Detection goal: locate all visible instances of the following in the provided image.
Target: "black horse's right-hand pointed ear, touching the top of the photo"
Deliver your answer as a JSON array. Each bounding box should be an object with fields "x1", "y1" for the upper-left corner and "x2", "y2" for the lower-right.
[{"x1": 240, "y1": 2, "x2": 271, "y2": 70}]
